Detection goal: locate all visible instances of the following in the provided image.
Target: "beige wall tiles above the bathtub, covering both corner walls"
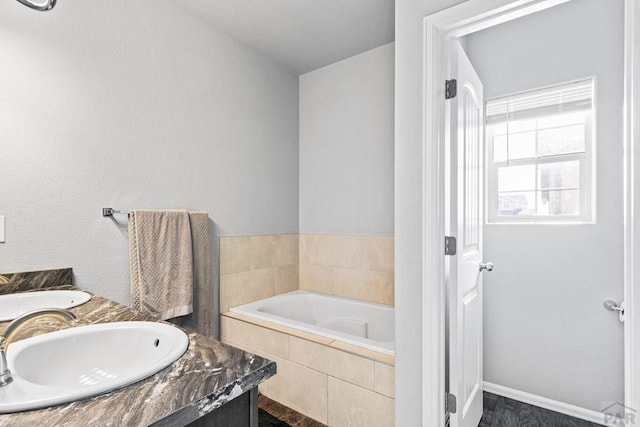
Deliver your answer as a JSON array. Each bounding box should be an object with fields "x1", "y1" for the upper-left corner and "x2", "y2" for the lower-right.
[{"x1": 220, "y1": 234, "x2": 394, "y2": 313}]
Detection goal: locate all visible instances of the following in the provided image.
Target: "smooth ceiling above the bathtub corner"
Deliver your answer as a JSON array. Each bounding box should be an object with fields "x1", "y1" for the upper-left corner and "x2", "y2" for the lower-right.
[{"x1": 177, "y1": 0, "x2": 395, "y2": 74}]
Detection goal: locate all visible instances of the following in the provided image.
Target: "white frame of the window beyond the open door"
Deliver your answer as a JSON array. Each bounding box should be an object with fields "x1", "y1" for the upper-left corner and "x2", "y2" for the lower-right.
[{"x1": 485, "y1": 82, "x2": 596, "y2": 224}]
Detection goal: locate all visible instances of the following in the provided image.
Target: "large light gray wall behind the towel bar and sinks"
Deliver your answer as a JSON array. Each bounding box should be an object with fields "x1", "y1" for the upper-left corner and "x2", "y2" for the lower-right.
[{"x1": 0, "y1": 0, "x2": 298, "y2": 303}]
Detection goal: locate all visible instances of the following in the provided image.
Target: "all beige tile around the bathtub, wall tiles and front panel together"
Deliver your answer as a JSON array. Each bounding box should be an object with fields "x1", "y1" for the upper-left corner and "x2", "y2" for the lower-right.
[{"x1": 220, "y1": 234, "x2": 395, "y2": 427}]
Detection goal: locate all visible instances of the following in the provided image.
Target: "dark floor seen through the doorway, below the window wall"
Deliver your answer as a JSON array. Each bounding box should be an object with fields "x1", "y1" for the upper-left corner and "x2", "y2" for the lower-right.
[{"x1": 478, "y1": 392, "x2": 600, "y2": 427}]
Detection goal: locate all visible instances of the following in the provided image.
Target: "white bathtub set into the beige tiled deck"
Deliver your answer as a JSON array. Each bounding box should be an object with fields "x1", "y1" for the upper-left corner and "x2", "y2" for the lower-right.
[{"x1": 230, "y1": 290, "x2": 394, "y2": 355}]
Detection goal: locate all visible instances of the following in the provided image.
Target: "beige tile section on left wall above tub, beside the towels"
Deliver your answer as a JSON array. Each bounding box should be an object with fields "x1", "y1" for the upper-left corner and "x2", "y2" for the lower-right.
[{"x1": 220, "y1": 234, "x2": 299, "y2": 313}]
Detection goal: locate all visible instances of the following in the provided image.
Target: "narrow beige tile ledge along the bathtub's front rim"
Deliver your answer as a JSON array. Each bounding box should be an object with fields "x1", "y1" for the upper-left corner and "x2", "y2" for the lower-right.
[{"x1": 221, "y1": 311, "x2": 395, "y2": 366}]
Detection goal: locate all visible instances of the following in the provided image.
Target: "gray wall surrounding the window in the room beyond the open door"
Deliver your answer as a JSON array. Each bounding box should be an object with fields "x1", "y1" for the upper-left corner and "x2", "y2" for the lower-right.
[{"x1": 467, "y1": 0, "x2": 624, "y2": 411}]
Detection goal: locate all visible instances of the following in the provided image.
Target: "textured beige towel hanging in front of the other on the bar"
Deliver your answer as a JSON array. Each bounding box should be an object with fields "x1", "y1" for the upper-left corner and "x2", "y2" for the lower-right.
[{"x1": 129, "y1": 210, "x2": 193, "y2": 320}]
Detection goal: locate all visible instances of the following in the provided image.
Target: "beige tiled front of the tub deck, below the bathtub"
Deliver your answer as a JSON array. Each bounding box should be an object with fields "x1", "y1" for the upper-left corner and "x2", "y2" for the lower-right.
[{"x1": 221, "y1": 313, "x2": 394, "y2": 427}]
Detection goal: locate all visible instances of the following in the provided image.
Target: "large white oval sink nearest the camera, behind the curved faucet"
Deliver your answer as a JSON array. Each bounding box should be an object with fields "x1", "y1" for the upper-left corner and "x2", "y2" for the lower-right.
[{"x1": 0, "y1": 322, "x2": 189, "y2": 413}]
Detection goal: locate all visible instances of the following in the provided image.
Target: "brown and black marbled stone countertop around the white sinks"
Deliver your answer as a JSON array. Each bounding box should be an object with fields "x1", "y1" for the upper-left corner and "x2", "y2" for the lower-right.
[{"x1": 0, "y1": 285, "x2": 276, "y2": 427}]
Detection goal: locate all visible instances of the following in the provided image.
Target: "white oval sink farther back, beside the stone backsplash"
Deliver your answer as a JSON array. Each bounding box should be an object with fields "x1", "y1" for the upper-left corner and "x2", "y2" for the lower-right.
[{"x1": 0, "y1": 291, "x2": 91, "y2": 322}]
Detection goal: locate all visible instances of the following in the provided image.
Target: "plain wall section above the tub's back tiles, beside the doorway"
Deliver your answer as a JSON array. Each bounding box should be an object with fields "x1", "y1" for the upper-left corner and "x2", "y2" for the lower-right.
[{"x1": 300, "y1": 43, "x2": 394, "y2": 235}]
